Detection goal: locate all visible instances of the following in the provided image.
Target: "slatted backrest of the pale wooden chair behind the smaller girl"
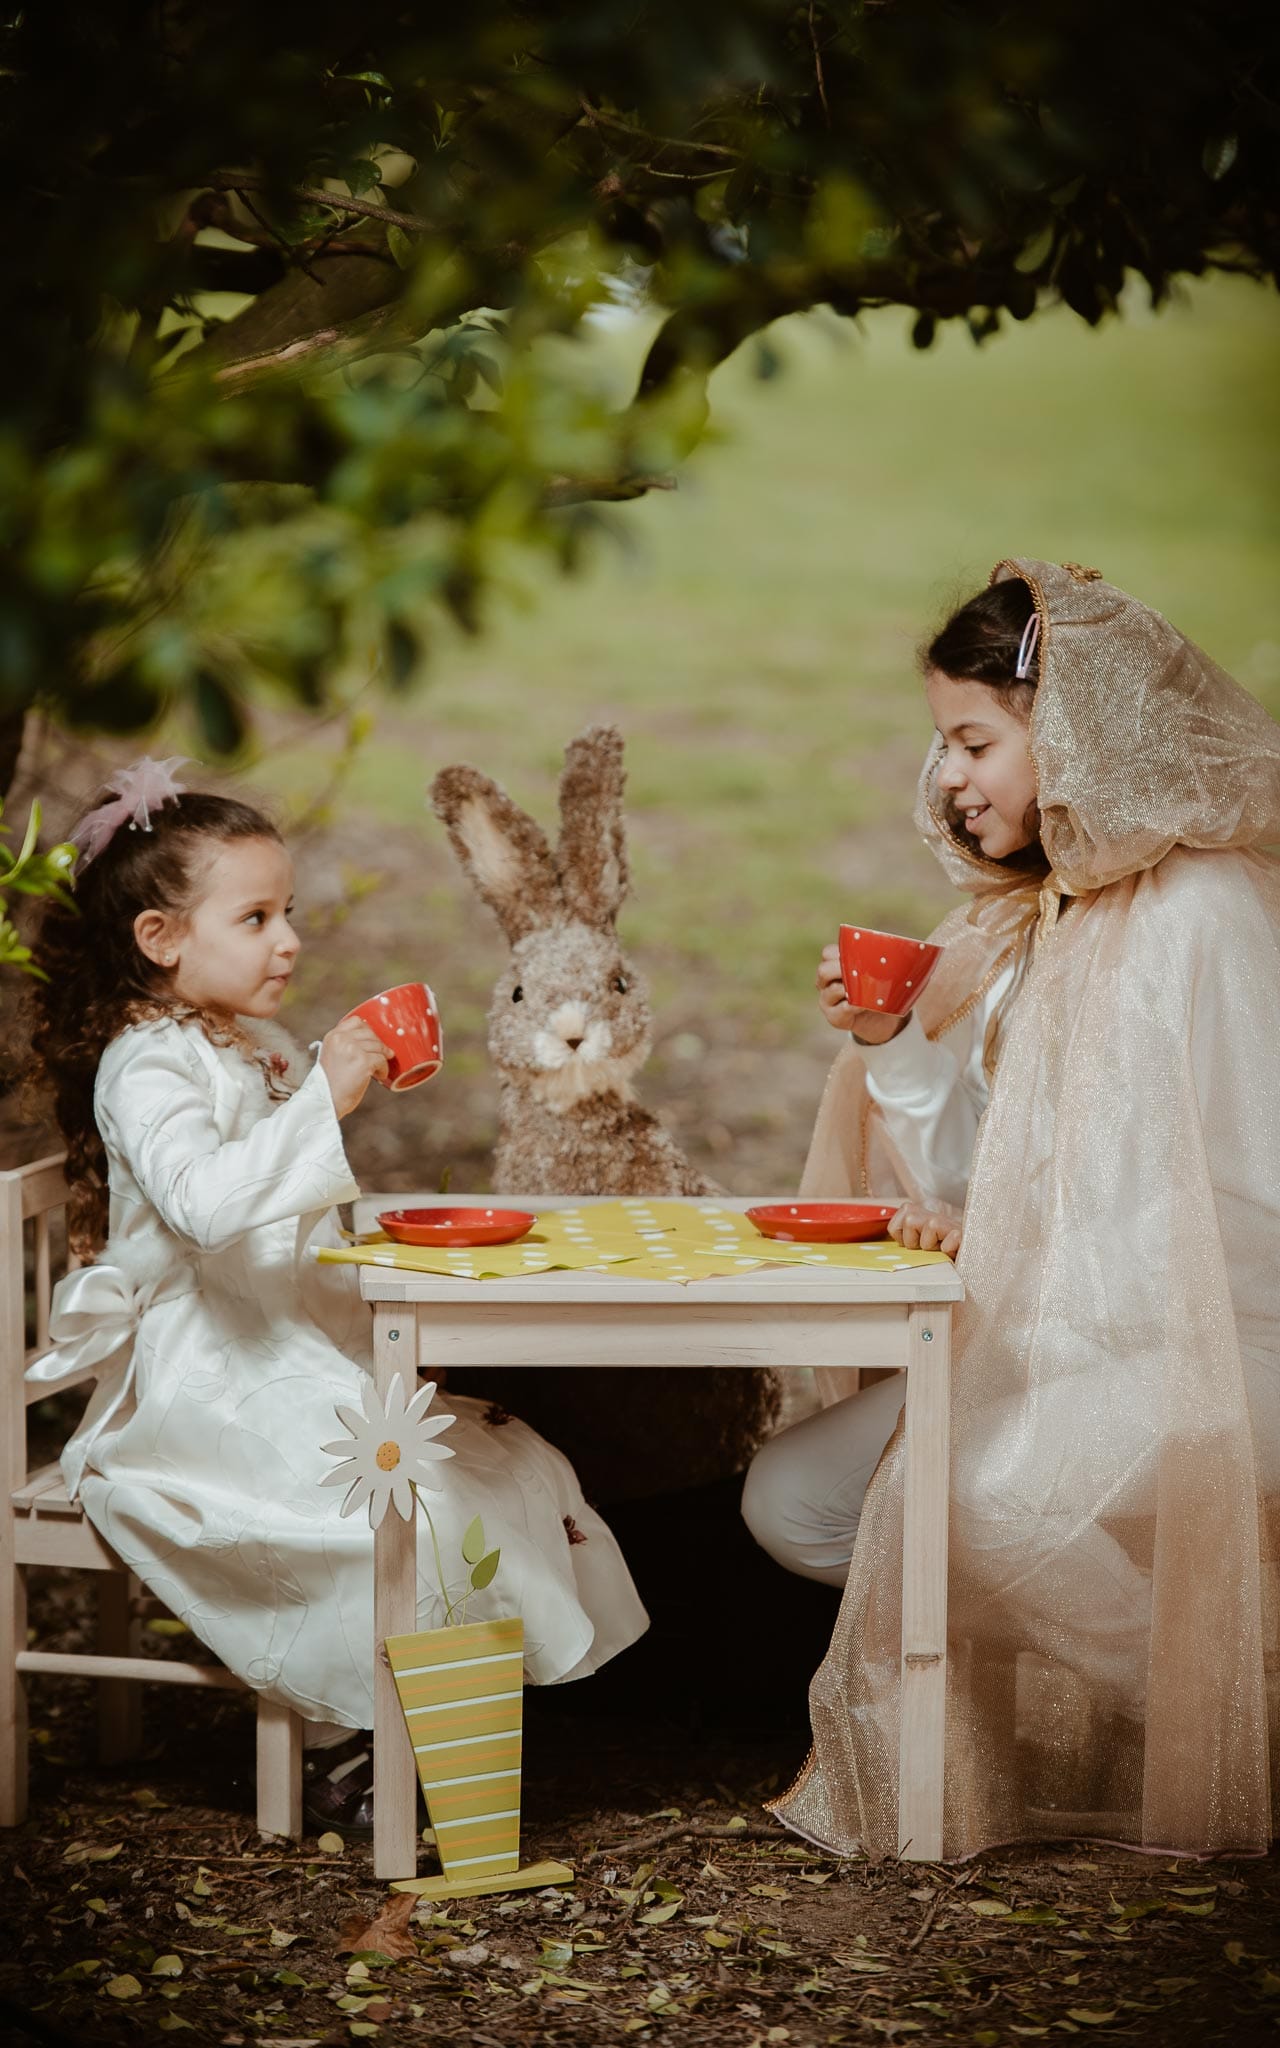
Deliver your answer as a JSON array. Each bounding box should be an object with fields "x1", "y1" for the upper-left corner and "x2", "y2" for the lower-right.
[{"x1": 0, "y1": 1153, "x2": 73, "y2": 1489}]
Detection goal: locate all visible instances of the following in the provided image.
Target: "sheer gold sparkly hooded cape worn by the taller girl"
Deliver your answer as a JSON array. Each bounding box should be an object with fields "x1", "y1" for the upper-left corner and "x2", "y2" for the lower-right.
[{"x1": 772, "y1": 561, "x2": 1280, "y2": 1858}]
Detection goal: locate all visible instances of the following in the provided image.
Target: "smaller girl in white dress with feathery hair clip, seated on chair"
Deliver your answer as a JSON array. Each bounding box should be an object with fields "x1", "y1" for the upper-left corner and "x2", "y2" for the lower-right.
[{"x1": 31, "y1": 762, "x2": 647, "y2": 1823}]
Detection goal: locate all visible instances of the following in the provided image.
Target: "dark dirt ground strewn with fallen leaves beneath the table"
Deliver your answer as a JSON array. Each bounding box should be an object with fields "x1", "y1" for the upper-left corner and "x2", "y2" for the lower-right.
[{"x1": 0, "y1": 1613, "x2": 1280, "y2": 2048}]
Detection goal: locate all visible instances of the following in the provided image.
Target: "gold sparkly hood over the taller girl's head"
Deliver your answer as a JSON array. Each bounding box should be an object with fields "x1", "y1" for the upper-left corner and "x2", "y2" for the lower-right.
[{"x1": 915, "y1": 559, "x2": 1280, "y2": 895}]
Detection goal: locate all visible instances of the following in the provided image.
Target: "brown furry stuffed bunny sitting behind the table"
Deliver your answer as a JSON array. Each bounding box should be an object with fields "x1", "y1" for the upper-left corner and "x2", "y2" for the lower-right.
[{"x1": 430, "y1": 725, "x2": 778, "y2": 1499}]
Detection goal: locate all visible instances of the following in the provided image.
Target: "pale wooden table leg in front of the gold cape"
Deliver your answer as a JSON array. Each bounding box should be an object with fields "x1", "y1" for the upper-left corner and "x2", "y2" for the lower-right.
[{"x1": 897, "y1": 1305, "x2": 950, "y2": 1862}]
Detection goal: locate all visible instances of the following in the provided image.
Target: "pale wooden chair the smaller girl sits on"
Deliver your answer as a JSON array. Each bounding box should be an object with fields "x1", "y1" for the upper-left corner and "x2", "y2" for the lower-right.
[{"x1": 0, "y1": 1155, "x2": 303, "y2": 1839}]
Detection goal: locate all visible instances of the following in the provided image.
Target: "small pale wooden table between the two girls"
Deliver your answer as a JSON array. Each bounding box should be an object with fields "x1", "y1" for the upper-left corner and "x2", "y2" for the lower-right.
[{"x1": 356, "y1": 1194, "x2": 965, "y2": 1878}]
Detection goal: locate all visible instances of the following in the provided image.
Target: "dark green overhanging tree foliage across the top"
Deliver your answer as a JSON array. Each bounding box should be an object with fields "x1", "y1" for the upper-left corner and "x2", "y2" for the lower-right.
[{"x1": 0, "y1": 0, "x2": 1280, "y2": 780}]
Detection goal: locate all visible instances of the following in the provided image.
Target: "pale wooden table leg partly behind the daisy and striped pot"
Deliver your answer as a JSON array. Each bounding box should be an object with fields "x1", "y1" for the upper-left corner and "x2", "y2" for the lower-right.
[{"x1": 373, "y1": 1300, "x2": 418, "y2": 1878}]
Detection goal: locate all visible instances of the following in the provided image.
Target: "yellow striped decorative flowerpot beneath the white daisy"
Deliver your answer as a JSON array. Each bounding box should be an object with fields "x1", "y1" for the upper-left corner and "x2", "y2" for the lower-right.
[{"x1": 387, "y1": 1616, "x2": 524, "y2": 1878}]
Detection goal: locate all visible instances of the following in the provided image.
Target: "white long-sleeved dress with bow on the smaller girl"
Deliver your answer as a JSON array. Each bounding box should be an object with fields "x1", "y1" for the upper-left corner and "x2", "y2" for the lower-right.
[{"x1": 31, "y1": 1020, "x2": 647, "y2": 1729}]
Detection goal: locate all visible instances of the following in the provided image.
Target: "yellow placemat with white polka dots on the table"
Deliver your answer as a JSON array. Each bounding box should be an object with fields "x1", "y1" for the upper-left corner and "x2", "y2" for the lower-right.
[{"x1": 317, "y1": 1198, "x2": 950, "y2": 1284}]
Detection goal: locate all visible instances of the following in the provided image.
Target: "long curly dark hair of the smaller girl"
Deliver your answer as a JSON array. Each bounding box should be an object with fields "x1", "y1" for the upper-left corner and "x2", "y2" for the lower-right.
[{"x1": 25, "y1": 791, "x2": 281, "y2": 1255}]
